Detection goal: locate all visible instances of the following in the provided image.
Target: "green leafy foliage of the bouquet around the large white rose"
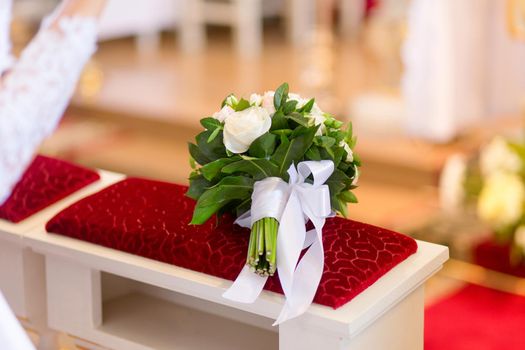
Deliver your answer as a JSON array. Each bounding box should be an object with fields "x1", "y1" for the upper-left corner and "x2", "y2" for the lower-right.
[{"x1": 187, "y1": 83, "x2": 361, "y2": 224}]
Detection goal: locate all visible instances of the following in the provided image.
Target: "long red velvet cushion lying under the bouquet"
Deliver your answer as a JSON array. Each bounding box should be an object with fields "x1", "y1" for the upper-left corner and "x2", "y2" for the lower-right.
[{"x1": 47, "y1": 179, "x2": 417, "y2": 308}]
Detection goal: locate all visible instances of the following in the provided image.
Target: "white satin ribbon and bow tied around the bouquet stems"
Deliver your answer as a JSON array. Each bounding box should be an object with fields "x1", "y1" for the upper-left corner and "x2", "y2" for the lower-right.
[{"x1": 223, "y1": 160, "x2": 334, "y2": 326}]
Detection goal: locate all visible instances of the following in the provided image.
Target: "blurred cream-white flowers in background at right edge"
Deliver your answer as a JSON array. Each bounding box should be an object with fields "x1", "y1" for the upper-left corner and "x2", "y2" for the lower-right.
[{"x1": 440, "y1": 136, "x2": 525, "y2": 261}]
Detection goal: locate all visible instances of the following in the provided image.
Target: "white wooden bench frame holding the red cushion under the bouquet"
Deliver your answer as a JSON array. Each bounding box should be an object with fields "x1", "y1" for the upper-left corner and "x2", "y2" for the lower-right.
[{"x1": 0, "y1": 168, "x2": 448, "y2": 350}]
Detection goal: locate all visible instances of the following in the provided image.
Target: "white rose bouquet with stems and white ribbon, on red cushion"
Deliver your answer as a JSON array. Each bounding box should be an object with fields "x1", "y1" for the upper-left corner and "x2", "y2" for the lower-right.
[{"x1": 187, "y1": 83, "x2": 360, "y2": 322}]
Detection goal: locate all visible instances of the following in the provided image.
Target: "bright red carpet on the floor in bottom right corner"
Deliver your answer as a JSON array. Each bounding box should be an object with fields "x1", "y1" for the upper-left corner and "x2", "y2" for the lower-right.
[{"x1": 425, "y1": 285, "x2": 525, "y2": 350}]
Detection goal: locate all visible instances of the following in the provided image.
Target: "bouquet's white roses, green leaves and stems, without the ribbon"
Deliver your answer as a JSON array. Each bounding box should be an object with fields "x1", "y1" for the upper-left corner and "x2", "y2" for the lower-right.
[{"x1": 188, "y1": 83, "x2": 361, "y2": 275}]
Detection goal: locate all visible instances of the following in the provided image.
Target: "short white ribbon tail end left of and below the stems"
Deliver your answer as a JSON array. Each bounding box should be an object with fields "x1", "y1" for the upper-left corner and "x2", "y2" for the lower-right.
[{"x1": 222, "y1": 265, "x2": 268, "y2": 304}]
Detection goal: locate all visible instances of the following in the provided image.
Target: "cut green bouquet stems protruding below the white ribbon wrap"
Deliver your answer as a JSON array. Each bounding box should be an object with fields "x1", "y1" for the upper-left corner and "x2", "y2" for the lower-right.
[{"x1": 246, "y1": 218, "x2": 279, "y2": 276}]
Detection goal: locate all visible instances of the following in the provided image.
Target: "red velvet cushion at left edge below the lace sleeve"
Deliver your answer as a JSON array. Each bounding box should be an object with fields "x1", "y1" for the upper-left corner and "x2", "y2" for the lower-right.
[{"x1": 0, "y1": 156, "x2": 100, "y2": 222}]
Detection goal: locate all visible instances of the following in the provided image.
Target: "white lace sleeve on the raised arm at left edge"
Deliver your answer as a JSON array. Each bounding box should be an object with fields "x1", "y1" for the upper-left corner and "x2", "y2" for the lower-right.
[{"x1": 0, "y1": 17, "x2": 97, "y2": 204}]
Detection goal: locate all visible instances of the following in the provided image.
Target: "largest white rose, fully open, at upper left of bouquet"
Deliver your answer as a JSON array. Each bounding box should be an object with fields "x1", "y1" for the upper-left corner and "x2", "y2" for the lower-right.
[{"x1": 224, "y1": 107, "x2": 272, "y2": 153}]
